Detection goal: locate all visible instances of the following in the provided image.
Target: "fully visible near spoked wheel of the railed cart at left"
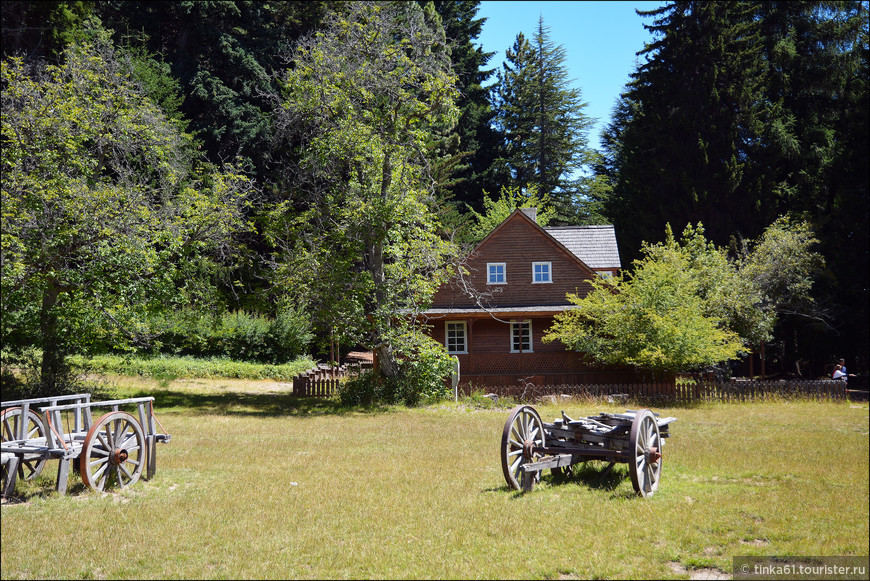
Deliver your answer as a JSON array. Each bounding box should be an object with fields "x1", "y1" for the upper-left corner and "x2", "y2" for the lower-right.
[{"x1": 79, "y1": 411, "x2": 145, "y2": 490}]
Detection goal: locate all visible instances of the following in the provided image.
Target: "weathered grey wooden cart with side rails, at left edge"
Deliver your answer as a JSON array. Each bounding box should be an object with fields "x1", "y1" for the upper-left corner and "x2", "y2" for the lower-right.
[{"x1": 0, "y1": 394, "x2": 171, "y2": 497}]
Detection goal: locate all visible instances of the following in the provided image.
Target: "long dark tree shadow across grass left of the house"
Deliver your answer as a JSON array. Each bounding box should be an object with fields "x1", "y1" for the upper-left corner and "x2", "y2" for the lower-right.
[{"x1": 122, "y1": 390, "x2": 392, "y2": 417}]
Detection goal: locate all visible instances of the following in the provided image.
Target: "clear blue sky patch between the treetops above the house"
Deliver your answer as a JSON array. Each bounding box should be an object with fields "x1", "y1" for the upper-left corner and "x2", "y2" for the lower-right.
[{"x1": 477, "y1": 0, "x2": 664, "y2": 147}]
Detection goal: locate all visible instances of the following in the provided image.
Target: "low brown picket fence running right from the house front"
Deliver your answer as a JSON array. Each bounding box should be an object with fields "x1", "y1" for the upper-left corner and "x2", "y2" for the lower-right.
[{"x1": 464, "y1": 380, "x2": 847, "y2": 403}]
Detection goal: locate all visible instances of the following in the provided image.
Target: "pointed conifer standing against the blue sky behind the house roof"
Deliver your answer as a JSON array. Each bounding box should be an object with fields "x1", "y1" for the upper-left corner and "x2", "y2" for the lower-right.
[{"x1": 496, "y1": 18, "x2": 592, "y2": 223}]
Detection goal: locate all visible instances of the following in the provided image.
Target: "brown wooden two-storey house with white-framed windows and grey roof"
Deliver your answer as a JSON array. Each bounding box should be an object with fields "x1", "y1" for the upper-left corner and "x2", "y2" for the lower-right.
[{"x1": 423, "y1": 208, "x2": 636, "y2": 386}]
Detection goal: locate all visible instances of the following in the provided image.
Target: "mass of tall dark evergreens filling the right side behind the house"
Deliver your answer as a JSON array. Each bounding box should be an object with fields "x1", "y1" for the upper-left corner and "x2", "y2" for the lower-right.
[{"x1": 596, "y1": 1, "x2": 868, "y2": 368}]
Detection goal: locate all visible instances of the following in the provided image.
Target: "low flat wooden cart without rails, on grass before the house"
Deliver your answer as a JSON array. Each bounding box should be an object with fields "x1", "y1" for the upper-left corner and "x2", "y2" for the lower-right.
[{"x1": 501, "y1": 405, "x2": 676, "y2": 497}]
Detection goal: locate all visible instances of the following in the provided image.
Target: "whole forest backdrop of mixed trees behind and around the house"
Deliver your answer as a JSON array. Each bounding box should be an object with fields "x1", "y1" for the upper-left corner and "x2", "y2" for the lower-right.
[{"x1": 2, "y1": 1, "x2": 870, "y2": 394}]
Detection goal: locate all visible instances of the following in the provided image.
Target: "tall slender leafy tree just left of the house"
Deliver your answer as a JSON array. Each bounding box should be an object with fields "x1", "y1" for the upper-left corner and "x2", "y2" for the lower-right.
[{"x1": 270, "y1": 2, "x2": 458, "y2": 376}]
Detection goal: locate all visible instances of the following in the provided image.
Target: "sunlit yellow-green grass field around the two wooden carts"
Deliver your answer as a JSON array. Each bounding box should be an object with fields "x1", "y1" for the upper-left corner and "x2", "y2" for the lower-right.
[{"x1": 2, "y1": 378, "x2": 870, "y2": 579}]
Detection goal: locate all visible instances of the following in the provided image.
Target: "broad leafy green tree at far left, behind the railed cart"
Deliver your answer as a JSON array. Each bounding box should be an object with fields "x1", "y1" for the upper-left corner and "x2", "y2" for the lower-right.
[{"x1": 2, "y1": 35, "x2": 248, "y2": 390}]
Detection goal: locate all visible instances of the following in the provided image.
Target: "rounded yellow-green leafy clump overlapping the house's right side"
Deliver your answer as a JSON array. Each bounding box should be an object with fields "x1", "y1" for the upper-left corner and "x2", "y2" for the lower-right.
[{"x1": 547, "y1": 219, "x2": 821, "y2": 372}]
